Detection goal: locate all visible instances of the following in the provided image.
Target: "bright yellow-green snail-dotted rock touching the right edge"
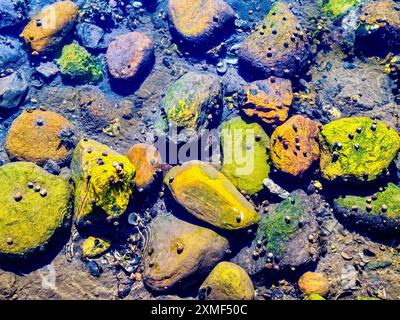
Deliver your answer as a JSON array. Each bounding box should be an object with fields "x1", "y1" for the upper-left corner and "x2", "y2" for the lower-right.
[{"x1": 320, "y1": 117, "x2": 400, "y2": 181}]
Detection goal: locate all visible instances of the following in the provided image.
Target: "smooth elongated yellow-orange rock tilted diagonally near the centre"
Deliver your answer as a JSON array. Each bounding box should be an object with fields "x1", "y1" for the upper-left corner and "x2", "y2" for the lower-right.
[{"x1": 164, "y1": 161, "x2": 258, "y2": 230}]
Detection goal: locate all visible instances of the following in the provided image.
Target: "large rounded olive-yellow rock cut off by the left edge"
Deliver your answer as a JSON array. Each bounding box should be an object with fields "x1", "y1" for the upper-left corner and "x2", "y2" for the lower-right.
[{"x1": 0, "y1": 162, "x2": 72, "y2": 257}]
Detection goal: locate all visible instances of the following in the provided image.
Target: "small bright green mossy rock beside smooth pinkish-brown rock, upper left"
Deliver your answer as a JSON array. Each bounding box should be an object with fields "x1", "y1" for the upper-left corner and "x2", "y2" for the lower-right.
[{"x1": 57, "y1": 44, "x2": 103, "y2": 83}]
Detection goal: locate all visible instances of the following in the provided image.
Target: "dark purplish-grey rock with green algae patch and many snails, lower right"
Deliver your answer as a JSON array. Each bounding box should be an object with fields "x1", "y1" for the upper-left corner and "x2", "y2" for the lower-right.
[{"x1": 231, "y1": 190, "x2": 327, "y2": 283}]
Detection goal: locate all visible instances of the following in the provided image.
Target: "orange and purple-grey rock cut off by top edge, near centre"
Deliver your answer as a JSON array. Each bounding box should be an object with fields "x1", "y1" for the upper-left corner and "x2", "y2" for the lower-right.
[{"x1": 168, "y1": 0, "x2": 235, "y2": 46}]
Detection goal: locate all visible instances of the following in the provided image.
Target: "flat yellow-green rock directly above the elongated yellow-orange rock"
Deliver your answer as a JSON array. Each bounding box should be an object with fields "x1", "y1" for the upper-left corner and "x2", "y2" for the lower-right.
[{"x1": 220, "y1": 117, "x2": 269, "y2": 194}]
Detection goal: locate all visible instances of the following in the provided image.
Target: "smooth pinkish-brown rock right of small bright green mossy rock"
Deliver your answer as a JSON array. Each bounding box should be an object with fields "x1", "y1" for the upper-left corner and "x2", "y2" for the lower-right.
[{"x1": 107, "y1": 32, "x2": 154, "y2": 80}]
